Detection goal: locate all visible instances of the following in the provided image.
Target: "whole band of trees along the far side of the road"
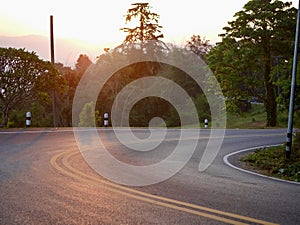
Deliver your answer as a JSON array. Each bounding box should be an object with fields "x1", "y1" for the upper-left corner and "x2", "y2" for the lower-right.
[{"x1": 0, "y1": 0, "x2": 300, "y2": 127}]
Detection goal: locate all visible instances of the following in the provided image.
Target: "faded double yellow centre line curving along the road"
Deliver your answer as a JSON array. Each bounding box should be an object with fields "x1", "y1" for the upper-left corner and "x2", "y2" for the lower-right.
[{"x1": 50, "y1": 151, "x2": 274, "y2": 225}]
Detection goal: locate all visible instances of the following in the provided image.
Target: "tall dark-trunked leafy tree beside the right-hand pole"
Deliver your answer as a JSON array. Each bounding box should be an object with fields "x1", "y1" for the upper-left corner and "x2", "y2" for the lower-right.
[{"x1": 210, "y1": 0, "x2": 297, "y2": 126}]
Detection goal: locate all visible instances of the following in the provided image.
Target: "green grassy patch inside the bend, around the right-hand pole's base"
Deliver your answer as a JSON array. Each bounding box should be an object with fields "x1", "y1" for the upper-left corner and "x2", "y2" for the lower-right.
[{"x1": 240, "y1": 133, "x2": 300, "y2": 182}]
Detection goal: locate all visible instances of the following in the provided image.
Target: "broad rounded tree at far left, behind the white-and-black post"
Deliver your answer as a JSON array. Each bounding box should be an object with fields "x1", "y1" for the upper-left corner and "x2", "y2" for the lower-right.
[{"x1": 0, "y1": 48, "x2": 58, "y2": 127}]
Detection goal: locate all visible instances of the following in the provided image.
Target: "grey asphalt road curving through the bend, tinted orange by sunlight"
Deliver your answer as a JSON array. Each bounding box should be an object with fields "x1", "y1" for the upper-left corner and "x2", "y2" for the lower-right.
[{"x1": 0, "y1": 129, "x2": 300, "y2": 225}]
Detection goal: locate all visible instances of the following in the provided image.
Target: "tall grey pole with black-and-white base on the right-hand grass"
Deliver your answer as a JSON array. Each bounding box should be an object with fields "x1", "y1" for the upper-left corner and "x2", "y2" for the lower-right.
[{"x1": 286, "y1": 0, "x2": 300, "y2": 159}]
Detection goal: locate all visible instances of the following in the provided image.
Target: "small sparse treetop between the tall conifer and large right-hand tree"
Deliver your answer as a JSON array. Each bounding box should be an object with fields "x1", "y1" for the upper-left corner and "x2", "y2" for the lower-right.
[{"x1": 185, "y1": 35, "x2": 213, "y2": 61}]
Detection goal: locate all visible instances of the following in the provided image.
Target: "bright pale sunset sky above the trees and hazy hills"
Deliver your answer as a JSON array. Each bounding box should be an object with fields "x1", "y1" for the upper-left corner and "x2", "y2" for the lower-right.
[{"x1": 0, "y1": 0, "x2": 298, "y2": 65}]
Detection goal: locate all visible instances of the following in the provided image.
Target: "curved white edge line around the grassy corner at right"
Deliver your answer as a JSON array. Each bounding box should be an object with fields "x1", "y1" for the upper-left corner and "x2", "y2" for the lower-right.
[{"x1": 223, "y1": 144, "x2": 300, "y2": 185}]
